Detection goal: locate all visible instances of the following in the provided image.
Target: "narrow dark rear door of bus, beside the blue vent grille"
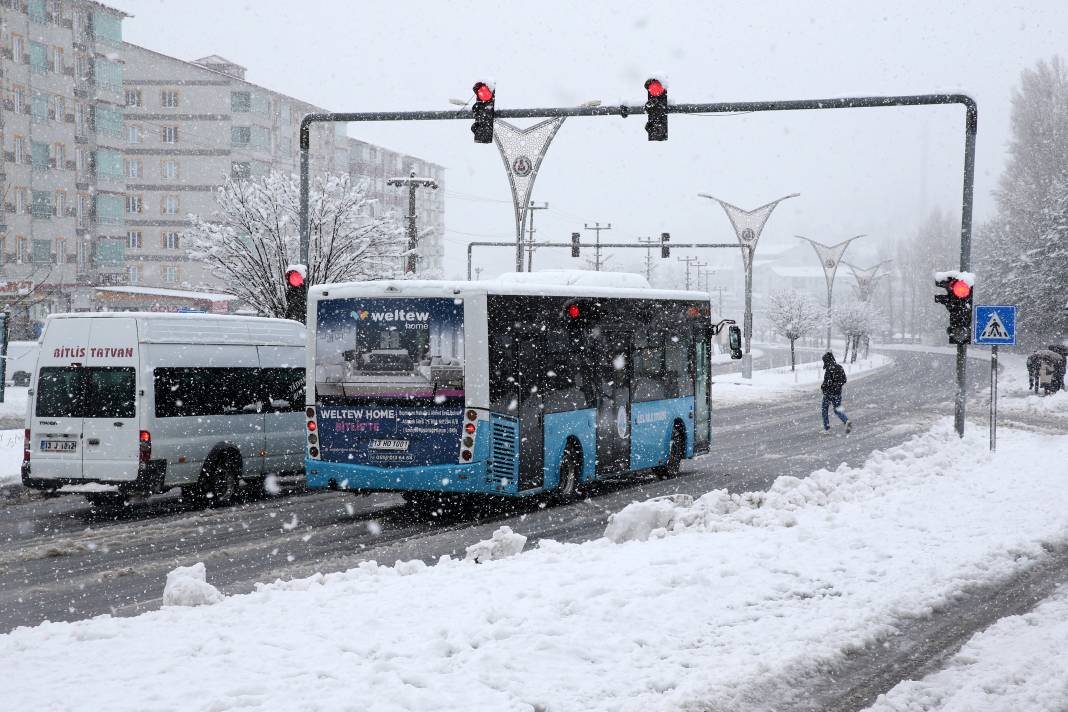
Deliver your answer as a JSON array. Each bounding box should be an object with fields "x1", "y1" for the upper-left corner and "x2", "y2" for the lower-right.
[{"x1": 515, "y1": 337, "x2": 545, "y2": 491}]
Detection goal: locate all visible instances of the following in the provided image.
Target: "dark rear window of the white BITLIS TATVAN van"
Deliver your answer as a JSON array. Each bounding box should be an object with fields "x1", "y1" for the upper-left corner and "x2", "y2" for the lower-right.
[{"x1": 36, "y1": 366, "x2": 137, "y2": 417}]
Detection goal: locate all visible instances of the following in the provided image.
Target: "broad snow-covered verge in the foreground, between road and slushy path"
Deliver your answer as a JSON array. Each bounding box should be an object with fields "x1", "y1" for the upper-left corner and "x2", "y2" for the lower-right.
[{"x1": 8, "y1": 422, "x2": 1068, "y2": 711}]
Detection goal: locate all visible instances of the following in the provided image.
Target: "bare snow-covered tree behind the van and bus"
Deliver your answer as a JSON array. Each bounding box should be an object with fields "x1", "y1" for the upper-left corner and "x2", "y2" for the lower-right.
[{"x1": 185, "y1": 173, "x2": 406, "y2": 317}]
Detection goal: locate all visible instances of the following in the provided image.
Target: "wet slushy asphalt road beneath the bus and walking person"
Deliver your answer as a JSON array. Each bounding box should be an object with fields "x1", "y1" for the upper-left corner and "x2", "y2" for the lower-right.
[{"x1": 0, "y1": 353, "x2": 984, "y2": 631}]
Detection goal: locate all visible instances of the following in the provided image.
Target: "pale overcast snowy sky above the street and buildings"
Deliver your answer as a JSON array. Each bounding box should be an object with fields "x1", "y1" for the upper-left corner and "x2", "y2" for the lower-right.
[{"x1": 106, "y1": 0, "x2": 1068, "y2": 273}]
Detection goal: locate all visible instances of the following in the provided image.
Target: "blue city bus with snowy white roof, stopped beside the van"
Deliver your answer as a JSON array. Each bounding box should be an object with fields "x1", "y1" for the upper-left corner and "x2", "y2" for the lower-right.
[{"x1": 305, "y1": 272, "x2": 730, "y2": 502}]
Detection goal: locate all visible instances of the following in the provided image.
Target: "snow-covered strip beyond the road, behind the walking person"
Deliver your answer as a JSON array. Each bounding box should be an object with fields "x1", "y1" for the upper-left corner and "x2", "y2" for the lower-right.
[{"x1": 712, "y1": 353, "x2": 893, "y2": 406}]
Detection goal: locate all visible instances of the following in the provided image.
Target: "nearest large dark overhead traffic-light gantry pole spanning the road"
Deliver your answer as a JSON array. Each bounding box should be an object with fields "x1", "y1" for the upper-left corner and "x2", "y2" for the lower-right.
[{"x1": 300, "y1": 94, "x2": 979, "y2": 437}]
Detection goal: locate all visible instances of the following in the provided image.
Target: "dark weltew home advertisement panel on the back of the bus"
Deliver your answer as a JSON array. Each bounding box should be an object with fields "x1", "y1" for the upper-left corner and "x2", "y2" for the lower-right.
[{"x1": 315, "y1": 298, "x2": 464, "y2": 466}]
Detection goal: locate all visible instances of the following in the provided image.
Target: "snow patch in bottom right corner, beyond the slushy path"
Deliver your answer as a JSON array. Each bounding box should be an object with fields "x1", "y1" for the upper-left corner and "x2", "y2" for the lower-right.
[{"x1": 868, "y1": 589, "x2": 1068, "y2": 712}]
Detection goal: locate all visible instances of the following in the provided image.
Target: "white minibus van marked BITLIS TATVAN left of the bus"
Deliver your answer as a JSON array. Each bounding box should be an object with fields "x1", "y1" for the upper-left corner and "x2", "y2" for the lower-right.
[{"x1": 22, "y1": 312, "x2": 307, "y2": 499}]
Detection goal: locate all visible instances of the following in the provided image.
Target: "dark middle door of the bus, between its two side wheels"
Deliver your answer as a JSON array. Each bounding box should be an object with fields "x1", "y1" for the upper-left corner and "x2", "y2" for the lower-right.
[{"x1": 593, "y1": 331, "x2": 633, "y2": 475}]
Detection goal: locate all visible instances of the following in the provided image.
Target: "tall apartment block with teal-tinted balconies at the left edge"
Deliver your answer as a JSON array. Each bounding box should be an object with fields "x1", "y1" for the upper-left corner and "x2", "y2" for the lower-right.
[{"x1": 0, "y1": 0, "x2": 126, "y2": 336}]
